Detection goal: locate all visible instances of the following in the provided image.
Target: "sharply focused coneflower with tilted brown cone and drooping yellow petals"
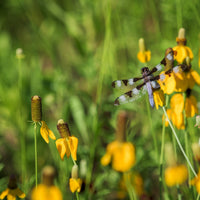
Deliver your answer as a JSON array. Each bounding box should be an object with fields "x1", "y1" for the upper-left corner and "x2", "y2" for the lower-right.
[{"x1": 56, "y1": 119, "x2": 78, "y2": 160}]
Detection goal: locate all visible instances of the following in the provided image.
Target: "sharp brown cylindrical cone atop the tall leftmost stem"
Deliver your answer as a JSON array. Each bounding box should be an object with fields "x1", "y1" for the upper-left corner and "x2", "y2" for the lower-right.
[{"x1": 31, "y1": 95, "x2": 42, "y2": 122}]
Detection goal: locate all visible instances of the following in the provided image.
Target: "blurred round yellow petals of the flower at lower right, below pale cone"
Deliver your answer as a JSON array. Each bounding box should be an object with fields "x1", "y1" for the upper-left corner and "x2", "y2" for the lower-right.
[{"x1": 165, "y1": 165, "x2": 188, "y2": 187}]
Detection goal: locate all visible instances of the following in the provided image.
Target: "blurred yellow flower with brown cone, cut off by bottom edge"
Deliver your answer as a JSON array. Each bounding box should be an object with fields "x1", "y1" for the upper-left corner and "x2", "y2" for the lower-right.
[{"x1": 31, "y1": 166, "x2": 63, "y2": 200}]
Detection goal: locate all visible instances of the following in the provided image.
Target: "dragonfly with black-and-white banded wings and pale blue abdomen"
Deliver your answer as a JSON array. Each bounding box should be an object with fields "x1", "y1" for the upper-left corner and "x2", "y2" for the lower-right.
[{"x1": 112, "y1": 48, "x2": 180, "y2": 108}]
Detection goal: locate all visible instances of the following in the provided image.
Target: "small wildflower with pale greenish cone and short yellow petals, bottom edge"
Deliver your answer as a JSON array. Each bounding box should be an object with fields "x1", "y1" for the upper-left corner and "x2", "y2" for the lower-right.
[{"x1": 69, "y1": 165, "x2": 82, "y2": 193}]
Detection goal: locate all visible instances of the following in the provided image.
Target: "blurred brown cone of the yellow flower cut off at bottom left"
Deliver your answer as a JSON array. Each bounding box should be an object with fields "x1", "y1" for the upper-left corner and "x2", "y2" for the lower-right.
[{"x1": 42, "y1": 166, "x2": 55, "y2": 186}]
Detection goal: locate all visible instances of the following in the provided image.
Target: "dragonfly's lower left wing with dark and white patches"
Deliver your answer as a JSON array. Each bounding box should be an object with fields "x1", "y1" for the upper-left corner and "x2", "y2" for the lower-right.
[{"x1": 114, "y1": 87, "x2": 145, "y2": 106}]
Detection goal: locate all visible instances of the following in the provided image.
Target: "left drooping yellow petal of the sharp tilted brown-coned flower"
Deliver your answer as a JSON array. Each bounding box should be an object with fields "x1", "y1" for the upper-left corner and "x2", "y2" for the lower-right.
[{"x1": 56, "y1": 138, "x2": 70, "y2": 160}]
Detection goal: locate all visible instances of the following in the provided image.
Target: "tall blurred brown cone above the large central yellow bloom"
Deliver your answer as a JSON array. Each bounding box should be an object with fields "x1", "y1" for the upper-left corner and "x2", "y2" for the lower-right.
[{"x1": 116, "y1": 111, "x2": 128, "y2": 142}]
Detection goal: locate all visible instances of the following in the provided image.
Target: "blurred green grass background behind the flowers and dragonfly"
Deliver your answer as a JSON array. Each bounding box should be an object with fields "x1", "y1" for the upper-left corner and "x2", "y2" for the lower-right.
[{"x1": 0, "y1": 0, "x2": 200, "y2": 199}]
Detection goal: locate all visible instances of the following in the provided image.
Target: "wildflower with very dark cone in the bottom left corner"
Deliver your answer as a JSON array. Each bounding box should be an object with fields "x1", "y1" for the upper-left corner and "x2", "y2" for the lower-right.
[{"x1": 0, "y1": 175, "x2": 26, "y2": 200}]
